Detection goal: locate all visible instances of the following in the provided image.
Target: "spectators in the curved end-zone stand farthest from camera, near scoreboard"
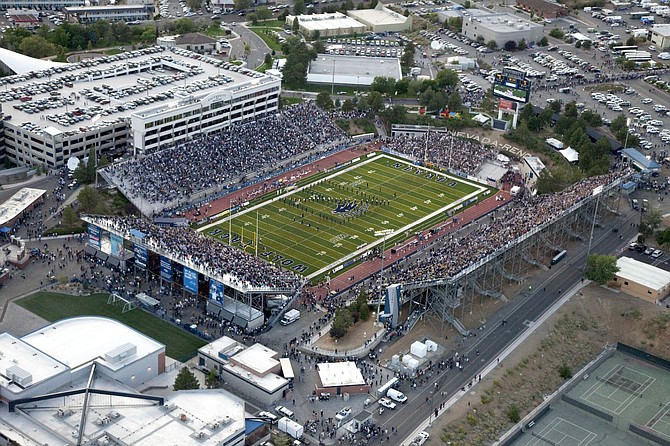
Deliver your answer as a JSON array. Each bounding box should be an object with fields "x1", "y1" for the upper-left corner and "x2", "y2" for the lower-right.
[{"x1": 384, "y1": 132, "x2": 496, "y2": 175}]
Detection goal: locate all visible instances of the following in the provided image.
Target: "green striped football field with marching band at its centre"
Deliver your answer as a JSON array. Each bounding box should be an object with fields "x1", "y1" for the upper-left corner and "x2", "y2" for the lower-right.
[{"x1": 199, "y1": 153, "x2": 489, "y2": 278}]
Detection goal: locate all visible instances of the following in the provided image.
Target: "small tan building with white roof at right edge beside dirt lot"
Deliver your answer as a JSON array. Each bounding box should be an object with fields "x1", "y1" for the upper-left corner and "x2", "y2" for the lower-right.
[{"x1": 610, "y1": 257, "x2": 670, "y2": 303}]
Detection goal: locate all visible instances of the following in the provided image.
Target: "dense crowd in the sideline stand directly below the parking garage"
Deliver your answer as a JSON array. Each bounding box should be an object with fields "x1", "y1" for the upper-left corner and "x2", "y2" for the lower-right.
[{"x1": 104, "y1": 102, "x2": 347, "y2": 209}]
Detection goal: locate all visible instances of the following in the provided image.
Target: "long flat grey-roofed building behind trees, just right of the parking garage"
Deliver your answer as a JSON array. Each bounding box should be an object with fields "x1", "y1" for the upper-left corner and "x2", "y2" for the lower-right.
[{"x1": 307, "y1": 54, "x2": 402, "y2": 86}]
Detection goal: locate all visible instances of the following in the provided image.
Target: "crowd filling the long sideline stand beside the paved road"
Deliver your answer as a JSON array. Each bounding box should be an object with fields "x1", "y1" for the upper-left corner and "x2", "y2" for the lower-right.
[{"x1": 390, "y1": 171, "x2": 626, "y2": 283}]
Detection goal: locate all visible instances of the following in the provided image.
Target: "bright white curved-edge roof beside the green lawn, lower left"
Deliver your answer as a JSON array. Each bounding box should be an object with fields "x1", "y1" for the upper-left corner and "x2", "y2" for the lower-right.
[{"x1": 21, "y1": 316, "x2": 165, "y2": 370}]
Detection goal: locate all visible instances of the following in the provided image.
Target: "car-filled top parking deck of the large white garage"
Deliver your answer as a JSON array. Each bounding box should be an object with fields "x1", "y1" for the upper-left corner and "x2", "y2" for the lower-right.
[{"x1": 0, "y1": 45, "x2": 273, "y2": 139}]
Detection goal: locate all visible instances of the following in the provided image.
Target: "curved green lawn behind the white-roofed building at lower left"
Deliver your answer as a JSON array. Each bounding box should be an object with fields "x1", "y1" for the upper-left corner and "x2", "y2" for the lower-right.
[{"x1": 16, "y1": 292, "x2": 206, "y2": 362}]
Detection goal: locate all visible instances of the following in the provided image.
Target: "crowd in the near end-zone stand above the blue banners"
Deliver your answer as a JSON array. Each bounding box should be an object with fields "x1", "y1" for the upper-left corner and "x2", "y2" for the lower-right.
[{"x1": 91, "y1": 216, "x2": 299, "y2": 289}]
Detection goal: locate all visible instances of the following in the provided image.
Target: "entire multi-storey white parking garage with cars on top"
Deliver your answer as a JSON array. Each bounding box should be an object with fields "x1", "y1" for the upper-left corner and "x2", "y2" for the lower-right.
[{"x1": 0, "y1": 47, "x2": 281, "y2": 168}]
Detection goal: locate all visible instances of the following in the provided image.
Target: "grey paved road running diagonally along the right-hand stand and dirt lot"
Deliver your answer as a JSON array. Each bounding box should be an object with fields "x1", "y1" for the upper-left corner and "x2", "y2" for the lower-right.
[{"x1": 375, "y1": 204, "x2": 639, "y2": 444}]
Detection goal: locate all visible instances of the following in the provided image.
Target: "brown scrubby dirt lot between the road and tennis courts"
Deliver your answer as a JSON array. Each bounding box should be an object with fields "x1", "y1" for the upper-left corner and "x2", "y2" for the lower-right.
[{"x1": 428, "y1": 285, "x2": 670, "y2": 446}]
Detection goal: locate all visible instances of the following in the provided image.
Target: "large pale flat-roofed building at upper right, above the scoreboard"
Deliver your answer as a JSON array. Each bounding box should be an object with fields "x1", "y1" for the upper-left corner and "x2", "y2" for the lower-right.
[{"x1": 461, "y1": 9, "x2": 544, "y2": 48}]
